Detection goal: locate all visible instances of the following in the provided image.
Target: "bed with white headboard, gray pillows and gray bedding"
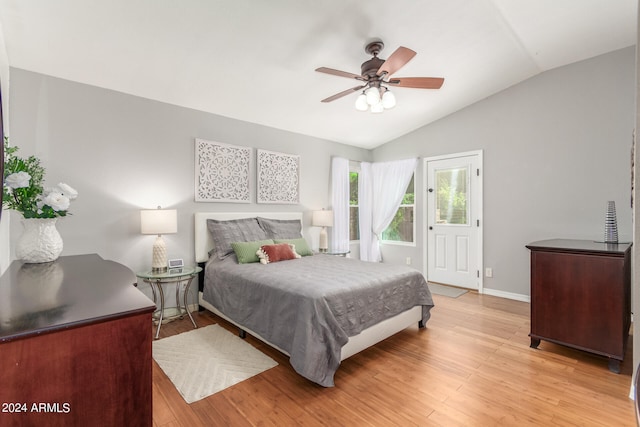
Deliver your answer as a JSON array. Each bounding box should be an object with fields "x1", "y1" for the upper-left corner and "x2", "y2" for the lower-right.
[{"x1": 195, "y1": 212, "x2": 433, "y2": 387}]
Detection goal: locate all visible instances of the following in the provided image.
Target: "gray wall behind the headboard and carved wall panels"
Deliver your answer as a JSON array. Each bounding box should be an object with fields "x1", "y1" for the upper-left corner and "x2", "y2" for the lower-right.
[{"x1": 5, "y1": 68, "x2": 371, "y2": 300}]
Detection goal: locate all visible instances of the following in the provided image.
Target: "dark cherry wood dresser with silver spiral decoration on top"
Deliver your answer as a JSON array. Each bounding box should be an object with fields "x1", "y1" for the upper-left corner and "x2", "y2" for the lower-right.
[{"x1": 527, "y1": 239, "x2": 631, "y2": 373}]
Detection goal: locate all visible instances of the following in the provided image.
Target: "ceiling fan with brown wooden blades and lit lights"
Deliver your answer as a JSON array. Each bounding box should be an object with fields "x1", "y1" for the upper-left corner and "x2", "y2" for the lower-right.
[{"x1": 316, "y1": 40, "x2": 444, "y2": 112}]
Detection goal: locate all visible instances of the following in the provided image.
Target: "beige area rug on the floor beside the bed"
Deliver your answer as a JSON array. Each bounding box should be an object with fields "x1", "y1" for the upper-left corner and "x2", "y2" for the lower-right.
[{"x1": 153, "y1": 325, "x2": 278, "y2": 403}]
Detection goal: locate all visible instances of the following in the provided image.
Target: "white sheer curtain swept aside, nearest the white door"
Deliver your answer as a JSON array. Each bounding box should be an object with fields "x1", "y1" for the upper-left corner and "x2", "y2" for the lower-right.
[{"x1": 358, "y1": 158, "x2": 418, "y2": 262}]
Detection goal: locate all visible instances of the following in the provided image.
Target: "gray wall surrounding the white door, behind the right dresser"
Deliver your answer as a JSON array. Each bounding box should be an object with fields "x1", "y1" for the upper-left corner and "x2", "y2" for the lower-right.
[{"x1": 374, "y1": 47, "x2": 635, "y2": 300}]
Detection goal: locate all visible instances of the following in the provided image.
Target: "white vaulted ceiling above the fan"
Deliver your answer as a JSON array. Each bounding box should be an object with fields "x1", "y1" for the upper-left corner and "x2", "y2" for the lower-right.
[{"x1": 0, "y1": 0, "x2": 637, "y2": 148}]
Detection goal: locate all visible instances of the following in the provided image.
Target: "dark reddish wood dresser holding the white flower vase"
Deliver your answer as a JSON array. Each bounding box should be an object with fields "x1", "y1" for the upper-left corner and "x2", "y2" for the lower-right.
[{"x1": 0, "y1": 255, "x2": 155, "y2": 426}]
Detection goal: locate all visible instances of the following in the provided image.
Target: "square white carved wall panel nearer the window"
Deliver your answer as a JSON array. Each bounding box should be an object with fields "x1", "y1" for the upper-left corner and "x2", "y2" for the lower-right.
[{"x1": 257, "y1": 150, "x2": 300, "y2": 204}]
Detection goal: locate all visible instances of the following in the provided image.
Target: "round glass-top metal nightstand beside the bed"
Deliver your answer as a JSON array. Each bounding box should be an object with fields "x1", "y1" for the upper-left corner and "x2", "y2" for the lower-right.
[{"x1": 136, "y1": 267, "x2": 202, "y2": 339}]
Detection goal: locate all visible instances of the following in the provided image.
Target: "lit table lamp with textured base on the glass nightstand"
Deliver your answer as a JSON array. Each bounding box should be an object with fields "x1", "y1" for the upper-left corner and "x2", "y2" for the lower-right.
[{"x1": 140, "y1": 206, "x2": 178, "y2": 273}]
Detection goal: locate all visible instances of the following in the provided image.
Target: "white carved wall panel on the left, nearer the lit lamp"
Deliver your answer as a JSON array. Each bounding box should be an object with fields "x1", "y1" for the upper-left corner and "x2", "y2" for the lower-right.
[{"x1": 195, "y1": 139, "x2": 252, "y2": 203}]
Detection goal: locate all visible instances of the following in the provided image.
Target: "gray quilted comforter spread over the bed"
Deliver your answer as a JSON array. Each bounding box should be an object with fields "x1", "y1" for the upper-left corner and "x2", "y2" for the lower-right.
[{"x1": 203, "y1": 255, "x2": 433, "y2": 387}]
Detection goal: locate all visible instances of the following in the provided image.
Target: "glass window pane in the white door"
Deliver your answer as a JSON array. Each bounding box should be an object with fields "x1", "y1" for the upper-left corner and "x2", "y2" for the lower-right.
[{"x1": 436, "y1": 168, "x2": 469, "y2": 225}]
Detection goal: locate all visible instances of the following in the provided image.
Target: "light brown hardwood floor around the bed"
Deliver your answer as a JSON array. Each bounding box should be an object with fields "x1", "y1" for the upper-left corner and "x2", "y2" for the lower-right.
[{"x1": 153, "y1": 292, "x2": 636, "y2": 427}]
